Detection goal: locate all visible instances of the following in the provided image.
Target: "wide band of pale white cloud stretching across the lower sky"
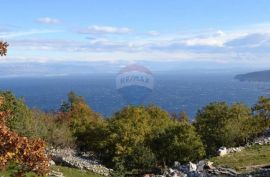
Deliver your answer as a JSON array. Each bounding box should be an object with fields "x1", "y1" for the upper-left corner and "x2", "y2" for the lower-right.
[{"x1": 5, "y1": 22, "x2": 270, "y2": 64}]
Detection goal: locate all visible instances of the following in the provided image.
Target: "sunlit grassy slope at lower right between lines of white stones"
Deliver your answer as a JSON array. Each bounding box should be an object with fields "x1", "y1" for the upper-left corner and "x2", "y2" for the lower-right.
[{"x1": 210, "y1": 145, "x2": 270, "y2": 172}]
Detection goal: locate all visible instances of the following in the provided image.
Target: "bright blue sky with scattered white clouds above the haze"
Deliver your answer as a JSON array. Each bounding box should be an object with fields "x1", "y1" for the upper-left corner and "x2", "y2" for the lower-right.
[{"x1": 0, "y1": 0, "x2": 270, "y2": 67}]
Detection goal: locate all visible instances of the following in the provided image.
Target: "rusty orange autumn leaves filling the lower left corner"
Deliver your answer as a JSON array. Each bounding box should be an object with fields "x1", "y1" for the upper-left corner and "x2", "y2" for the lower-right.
[{"x1": 0, "y1": 98, "x2": 49, "y2": 176}]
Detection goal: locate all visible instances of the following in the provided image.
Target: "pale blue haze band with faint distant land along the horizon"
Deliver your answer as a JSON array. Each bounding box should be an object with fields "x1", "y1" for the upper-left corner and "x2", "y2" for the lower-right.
[{"x1": 0, "y1": 60, "x2": 270, "y2": 78}]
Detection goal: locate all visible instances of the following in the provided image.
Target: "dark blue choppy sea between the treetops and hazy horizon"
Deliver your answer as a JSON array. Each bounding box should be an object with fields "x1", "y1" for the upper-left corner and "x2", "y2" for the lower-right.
[{"x1": 0, "y1": 73, "x2": 270, "y2": 119}]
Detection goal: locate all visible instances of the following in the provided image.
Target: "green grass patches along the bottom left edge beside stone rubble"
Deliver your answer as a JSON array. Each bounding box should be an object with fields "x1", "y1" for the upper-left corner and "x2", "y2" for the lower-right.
[{"x1": 0, "y1": 166, "x2": 104, "y2": 177}]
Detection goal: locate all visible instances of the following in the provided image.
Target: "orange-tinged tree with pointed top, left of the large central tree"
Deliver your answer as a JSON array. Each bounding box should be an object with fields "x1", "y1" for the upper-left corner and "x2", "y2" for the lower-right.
[{"x1": 57, "y1": 92, "x2": 105, "y2": 153}]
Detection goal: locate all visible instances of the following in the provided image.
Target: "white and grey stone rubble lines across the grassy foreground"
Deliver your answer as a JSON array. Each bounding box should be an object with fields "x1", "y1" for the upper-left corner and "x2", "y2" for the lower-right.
[{"x1": 48, "y1": 133, "x2": 270, "y2": 177}]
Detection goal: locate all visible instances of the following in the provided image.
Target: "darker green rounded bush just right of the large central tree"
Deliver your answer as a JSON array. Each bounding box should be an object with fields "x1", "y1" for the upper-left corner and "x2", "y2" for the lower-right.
[{"x1": 152, "y1": 121, "x2": 205, "y2": 165}]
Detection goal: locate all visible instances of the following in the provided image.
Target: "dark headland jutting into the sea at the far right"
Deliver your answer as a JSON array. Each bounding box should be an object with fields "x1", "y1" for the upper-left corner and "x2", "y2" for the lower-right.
[{"x1": 235, "y1": 70, "x2": 270, "y2": 82}]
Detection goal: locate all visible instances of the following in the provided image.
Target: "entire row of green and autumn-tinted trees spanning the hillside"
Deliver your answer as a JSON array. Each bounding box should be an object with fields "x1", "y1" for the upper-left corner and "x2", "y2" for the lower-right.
[{"x1": 0, "y1": 88, "x2": 270, "y2": 176}]
